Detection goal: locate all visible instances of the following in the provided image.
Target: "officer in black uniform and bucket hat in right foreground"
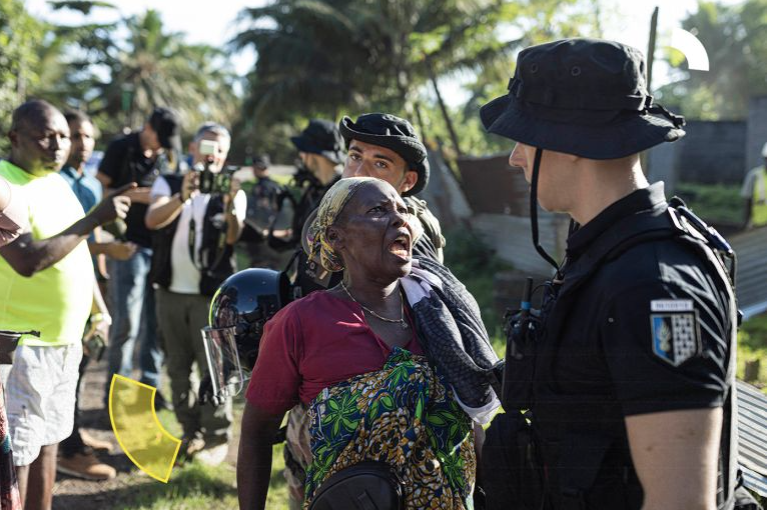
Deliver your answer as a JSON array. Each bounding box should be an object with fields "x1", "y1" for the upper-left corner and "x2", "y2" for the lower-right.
[{"x1": 481, "y1": 39, "x2": 737, "y2": 510}]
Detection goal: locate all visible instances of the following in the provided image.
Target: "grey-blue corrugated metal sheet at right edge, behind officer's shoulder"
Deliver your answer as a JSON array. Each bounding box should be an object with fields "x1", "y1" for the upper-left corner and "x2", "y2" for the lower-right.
[{"x1": 729, "y1": 227, "x2": 766, "y2": 318}]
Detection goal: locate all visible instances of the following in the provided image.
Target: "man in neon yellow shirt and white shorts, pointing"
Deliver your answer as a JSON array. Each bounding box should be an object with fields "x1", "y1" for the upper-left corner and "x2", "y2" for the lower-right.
[{"x1": 0, "y1": 101, "x2": 135, "y2": 510}]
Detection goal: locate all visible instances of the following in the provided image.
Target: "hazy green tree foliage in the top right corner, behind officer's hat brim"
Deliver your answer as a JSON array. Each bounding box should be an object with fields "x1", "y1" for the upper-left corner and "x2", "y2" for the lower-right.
[{"x1": 655, "y1": 0, "x2": 767, "y2": 120}]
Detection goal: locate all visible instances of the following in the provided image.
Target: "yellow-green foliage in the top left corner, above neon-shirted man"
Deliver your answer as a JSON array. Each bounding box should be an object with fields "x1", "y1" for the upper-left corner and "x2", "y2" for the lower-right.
[{"x1": 0, "y1": 0, "x2": 46, "y2": 152}]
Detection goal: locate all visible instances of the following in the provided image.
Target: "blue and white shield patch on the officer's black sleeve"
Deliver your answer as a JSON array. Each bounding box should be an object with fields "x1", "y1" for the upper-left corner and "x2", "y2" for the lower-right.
[{"x1": 650, "y1": 299, "x2": 702, "y2": 367}]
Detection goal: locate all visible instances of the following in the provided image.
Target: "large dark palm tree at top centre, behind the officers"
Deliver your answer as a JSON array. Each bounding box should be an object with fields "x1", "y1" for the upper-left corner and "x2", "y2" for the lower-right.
[{"x1": 233, "y1": 0, "x2": 517, "y2": 153}]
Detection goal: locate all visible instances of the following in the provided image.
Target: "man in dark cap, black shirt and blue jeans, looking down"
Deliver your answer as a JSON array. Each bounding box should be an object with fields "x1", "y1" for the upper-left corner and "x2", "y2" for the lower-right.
[{"x1": 96, "y1": 107, "x2": 181, "y2": 407}]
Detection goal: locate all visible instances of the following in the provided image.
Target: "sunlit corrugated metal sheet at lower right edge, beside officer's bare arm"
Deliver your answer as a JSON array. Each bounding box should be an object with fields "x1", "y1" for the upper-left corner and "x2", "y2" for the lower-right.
[{"x1": 737, "y1": 381, "x2": 767, "y2": 497}]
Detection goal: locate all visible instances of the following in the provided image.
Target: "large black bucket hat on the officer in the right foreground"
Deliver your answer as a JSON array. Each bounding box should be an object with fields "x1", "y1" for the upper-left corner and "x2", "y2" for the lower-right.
[{"x1": 480, "y1": 39, "x2": 686, "y2": 159}]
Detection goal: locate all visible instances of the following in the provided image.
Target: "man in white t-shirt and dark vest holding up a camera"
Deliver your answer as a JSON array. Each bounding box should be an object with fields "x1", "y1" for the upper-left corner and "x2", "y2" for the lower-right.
[{"x1": 145, "y1": 123, "x2": 242, "y2": 463}]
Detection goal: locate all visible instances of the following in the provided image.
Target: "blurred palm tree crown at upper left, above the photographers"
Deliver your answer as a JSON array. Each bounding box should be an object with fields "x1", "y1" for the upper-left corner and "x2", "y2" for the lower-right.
[{"x1": 27, "y1": 5, "x2": 238, "y2": 143}]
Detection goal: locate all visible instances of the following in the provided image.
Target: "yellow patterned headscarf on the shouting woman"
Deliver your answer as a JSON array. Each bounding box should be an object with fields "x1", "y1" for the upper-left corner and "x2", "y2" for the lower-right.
[{"x1": 306, "y1": 177, "x2": 422, "y2": 272}]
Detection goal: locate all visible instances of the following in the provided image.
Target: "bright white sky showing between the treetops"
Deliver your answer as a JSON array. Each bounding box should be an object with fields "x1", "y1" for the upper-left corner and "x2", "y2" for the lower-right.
[{"x1": 25, "y1": 0, "x2": 740, "y2": 105}]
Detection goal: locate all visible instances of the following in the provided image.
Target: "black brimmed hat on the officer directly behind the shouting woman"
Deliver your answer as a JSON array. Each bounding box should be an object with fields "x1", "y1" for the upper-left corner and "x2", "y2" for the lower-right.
[{"x1": 339, "y1": 113, "x2": 430, "y2": 196}]
